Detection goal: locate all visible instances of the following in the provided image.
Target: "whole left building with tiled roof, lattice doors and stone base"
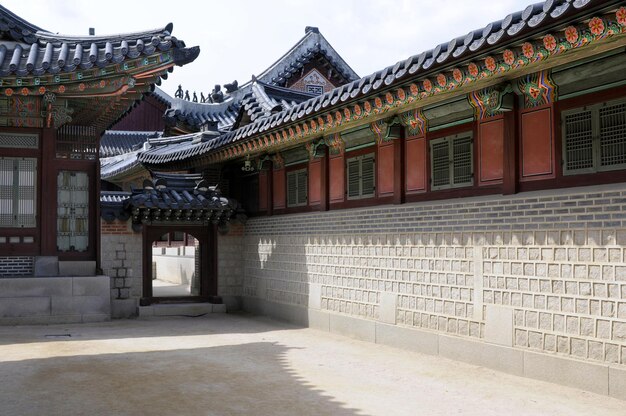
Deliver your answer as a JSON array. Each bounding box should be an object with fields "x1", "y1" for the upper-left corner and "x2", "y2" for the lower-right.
[{"x1": 0, "y1": 6, "x2": 200, "y2": 323}]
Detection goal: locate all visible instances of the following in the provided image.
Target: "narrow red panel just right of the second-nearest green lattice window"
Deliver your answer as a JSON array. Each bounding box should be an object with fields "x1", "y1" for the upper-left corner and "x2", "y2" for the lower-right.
[{"x1": 478, "y1": 119, "x2": 504, "y2": 185}]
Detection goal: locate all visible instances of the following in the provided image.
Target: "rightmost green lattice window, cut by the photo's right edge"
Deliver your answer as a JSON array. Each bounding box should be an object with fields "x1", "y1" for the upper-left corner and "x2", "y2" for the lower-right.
[{"x1": 562, "y1": 100, "x2": 626, "y2": 175}]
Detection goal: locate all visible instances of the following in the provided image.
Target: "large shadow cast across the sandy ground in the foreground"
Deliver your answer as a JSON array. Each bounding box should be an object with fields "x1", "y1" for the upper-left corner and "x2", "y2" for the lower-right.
[{"x1": 0, "y1": 342, "x2": 359, "y2": 416}]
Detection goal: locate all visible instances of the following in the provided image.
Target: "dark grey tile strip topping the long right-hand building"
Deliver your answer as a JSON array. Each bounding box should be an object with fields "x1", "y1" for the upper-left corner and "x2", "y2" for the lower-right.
[{"x1": 139, "y1": 0, "x2": 623, "y2": 169}]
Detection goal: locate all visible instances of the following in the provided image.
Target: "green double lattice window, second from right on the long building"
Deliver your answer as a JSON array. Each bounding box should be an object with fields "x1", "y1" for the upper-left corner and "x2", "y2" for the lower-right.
[{"x1": 430, "y1": 133, "x2": 474, "y2": 190}]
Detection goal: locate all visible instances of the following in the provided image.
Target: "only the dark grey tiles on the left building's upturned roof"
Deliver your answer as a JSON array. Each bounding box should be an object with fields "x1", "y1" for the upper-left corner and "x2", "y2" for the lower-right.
[{"x1": 0, "y1": 6, "x2": 199, "y2": 76}]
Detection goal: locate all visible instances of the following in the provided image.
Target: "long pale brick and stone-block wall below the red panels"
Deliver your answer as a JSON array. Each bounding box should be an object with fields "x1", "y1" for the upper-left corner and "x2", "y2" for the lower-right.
[{"x1": 235, "y1": 184, "x2": 626, "y2": 398}]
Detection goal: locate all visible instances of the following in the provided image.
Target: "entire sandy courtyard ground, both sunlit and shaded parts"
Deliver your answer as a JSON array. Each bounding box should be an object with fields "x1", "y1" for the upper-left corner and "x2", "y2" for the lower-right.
[{"x1": 0, "y1": 315, "x2": 626, "y2": 416}]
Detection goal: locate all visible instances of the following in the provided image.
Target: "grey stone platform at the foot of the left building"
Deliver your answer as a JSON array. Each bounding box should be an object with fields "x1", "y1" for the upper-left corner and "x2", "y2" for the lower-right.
[{"x1": 0, "y1": 276, "x2": 111, "y2": 325}]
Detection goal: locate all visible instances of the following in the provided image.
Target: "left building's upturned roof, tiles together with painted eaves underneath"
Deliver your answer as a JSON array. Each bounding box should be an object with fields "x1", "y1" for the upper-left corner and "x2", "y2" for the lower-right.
[{"x1": 0, "y1": 6, "x2": 200, "y2": 132}]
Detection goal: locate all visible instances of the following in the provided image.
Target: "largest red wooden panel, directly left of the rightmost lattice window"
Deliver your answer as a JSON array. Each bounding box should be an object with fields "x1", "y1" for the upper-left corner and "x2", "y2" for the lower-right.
[{"x1": 520, "y1": 108, "x2": 554, "y2": 181}]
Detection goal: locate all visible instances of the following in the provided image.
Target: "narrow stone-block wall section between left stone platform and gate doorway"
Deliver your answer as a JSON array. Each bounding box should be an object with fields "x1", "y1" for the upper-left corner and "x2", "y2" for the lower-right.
[{"x1": 100, "y1": 220, "x2": 143, "y2": 318}]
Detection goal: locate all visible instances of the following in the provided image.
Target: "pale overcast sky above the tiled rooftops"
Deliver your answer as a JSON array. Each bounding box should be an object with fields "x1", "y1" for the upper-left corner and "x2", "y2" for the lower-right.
[{"x1": 0, "y1": 0, "x2": 533, "y2": 96}]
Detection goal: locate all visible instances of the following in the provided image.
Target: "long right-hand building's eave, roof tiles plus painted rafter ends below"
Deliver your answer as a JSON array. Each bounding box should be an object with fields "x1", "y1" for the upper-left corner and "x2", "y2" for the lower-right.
[{"x1": 139, "y1": 0, "x2": 626, "y2": 168}]
